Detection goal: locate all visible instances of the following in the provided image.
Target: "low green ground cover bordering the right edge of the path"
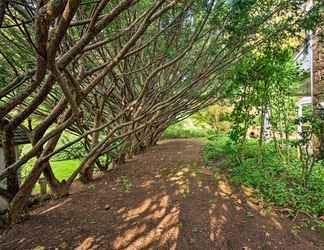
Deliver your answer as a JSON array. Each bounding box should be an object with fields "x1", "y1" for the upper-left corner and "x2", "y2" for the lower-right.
[{"x1": 203, "y1": 136, "x2": 324, "y2": 216}]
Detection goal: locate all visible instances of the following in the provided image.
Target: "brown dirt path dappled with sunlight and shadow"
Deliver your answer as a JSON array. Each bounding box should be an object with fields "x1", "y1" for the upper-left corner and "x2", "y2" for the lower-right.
[{"x1": 0, "y1": 140, "x2": 324, "y2": 250}]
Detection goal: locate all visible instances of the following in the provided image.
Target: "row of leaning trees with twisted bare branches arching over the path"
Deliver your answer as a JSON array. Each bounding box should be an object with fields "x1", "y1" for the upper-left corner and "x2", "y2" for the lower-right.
[{"x1": 0, "y1": 0, "x2": 321, "y2": 225}]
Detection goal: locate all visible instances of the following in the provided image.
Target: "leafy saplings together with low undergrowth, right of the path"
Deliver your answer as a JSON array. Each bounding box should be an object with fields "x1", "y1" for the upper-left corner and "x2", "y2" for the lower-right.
[{"x1": 204, "y1": 42, "x2": 324, "y2": 223}]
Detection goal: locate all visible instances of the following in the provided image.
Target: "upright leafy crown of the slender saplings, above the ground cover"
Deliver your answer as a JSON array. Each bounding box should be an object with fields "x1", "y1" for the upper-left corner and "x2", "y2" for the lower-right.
[{"x1": 226, "y1": 45, "x2": 302, "y2": 142}]
